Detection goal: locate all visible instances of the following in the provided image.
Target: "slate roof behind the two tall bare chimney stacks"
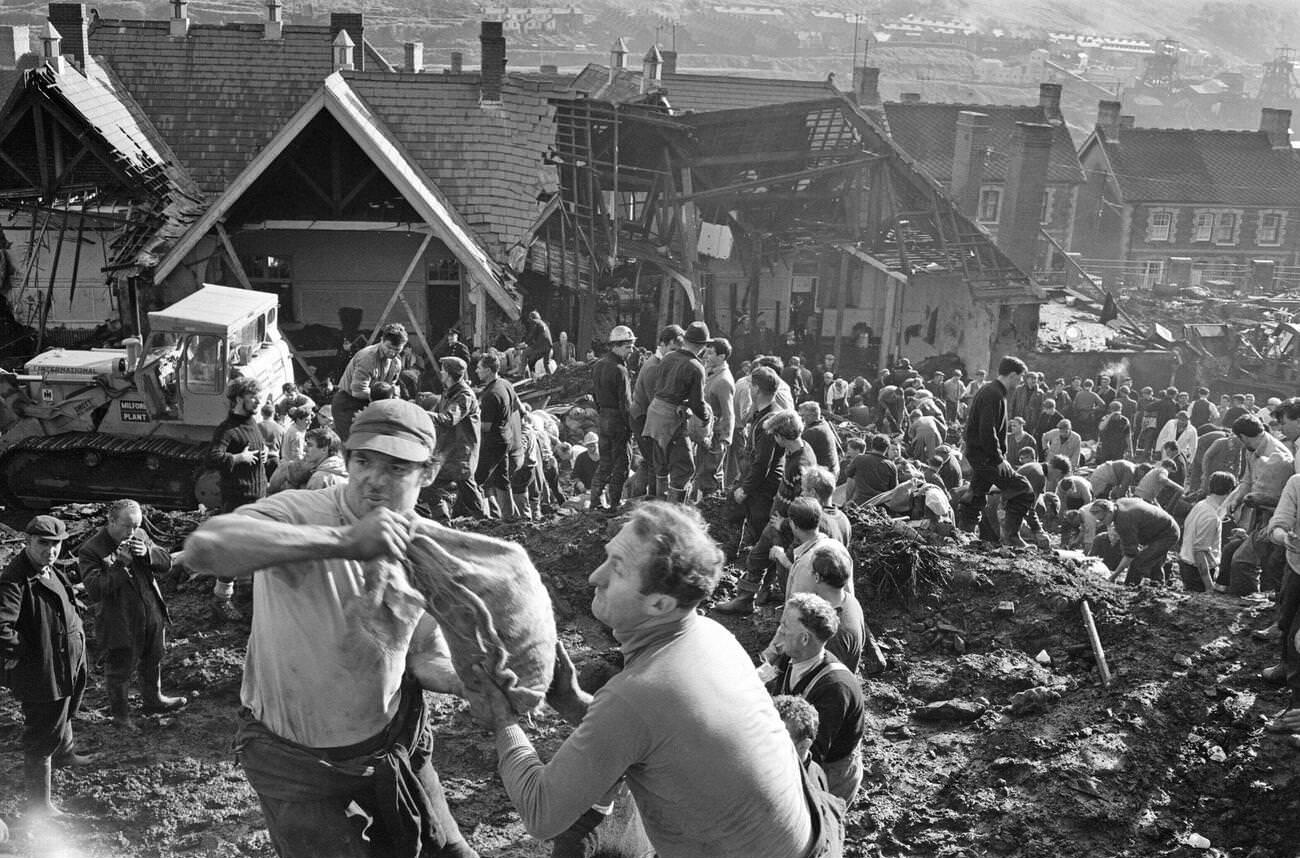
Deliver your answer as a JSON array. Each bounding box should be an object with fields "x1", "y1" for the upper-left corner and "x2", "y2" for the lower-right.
[{"x1": 884, "y1": 101, "x2": 1084, "y2": 185}]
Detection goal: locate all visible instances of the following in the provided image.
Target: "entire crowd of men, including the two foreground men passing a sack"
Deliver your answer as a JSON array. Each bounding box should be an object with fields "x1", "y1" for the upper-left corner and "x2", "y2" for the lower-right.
[{"x1": 0, "y1": 312, "x2": 1300, "y2": 858}]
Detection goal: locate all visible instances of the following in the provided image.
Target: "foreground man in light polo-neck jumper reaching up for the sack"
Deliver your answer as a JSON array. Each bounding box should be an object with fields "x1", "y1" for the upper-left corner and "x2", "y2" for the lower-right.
[{"x1": 460, "y1": 502, "x2": 833, "y2": 858}]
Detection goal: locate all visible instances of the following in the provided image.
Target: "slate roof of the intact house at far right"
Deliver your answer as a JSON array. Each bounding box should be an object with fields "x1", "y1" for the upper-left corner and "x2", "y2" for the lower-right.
[{"x1": 1096, "y1": 129, "x2": 1300, "y2": 208}]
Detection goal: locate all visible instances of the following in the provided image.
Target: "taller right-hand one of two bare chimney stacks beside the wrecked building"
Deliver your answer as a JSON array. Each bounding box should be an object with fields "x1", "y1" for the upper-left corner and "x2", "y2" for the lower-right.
[{"x1": 997, "y1": 122, "x2": 1056, "y2": 274}]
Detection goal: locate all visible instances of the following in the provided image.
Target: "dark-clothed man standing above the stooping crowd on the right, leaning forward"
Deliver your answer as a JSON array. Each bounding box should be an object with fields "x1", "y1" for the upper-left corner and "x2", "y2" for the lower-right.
[{"x1": 958, "y1": 356, "x2": 1043, "y2": 546}]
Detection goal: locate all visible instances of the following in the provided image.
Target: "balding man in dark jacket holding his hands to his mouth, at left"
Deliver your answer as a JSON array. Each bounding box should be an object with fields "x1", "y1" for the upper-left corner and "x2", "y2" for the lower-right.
[{"x1": 77, "y1": 501, "x2": 186, "y2": 728}]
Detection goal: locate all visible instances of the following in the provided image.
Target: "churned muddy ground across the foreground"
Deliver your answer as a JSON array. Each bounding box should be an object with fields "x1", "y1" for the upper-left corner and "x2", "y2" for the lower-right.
[{"x1": 0, "y1": 507, "x2": 1300, "y2": 858}]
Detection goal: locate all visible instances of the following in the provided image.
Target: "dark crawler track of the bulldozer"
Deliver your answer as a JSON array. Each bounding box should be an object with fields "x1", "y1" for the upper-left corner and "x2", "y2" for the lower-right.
[{"x1": 0, "y1": 432, "x2": 208, "y2": 510}]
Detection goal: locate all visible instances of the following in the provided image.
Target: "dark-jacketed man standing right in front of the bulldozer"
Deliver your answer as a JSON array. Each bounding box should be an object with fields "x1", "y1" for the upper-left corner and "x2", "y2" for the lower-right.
[{"x1": 208, "y1": 378, "x2": 268, "y2": 621}]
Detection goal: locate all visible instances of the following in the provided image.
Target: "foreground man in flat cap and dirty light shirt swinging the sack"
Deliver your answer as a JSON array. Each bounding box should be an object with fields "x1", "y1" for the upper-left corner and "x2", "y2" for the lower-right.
[{"x1": 183, "y1": 399, "x2": 480, "y2": 858}]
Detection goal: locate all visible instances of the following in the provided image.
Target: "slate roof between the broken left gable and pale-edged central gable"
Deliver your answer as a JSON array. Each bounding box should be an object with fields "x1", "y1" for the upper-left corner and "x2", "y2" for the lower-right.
[{"x1": 90, "y1": 18, "x2": 345, "y2": 194}]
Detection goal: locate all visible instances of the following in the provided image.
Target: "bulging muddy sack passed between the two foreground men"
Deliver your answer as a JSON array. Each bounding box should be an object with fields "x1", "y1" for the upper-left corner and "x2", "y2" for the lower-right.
[{"x1": 406, "y1": 520, "x2": 556, "y2": 715}]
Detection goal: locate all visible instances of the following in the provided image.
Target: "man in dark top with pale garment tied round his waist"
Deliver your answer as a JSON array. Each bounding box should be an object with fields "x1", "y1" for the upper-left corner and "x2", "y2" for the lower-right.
[{"x1": 641, "y1": 321, "x2": 712, "y2": 503}]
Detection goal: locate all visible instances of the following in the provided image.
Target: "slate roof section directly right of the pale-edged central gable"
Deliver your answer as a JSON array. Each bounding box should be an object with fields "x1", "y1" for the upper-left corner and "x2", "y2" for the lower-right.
[{"x1": 343, "y1": 72, "x2": 567, "y2": 254}]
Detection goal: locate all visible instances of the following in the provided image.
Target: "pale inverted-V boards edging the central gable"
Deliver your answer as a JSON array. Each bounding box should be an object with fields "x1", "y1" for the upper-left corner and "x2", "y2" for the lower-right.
[{"x1": 153, "y1": 73, "x2": 520, "y2": 319}]
